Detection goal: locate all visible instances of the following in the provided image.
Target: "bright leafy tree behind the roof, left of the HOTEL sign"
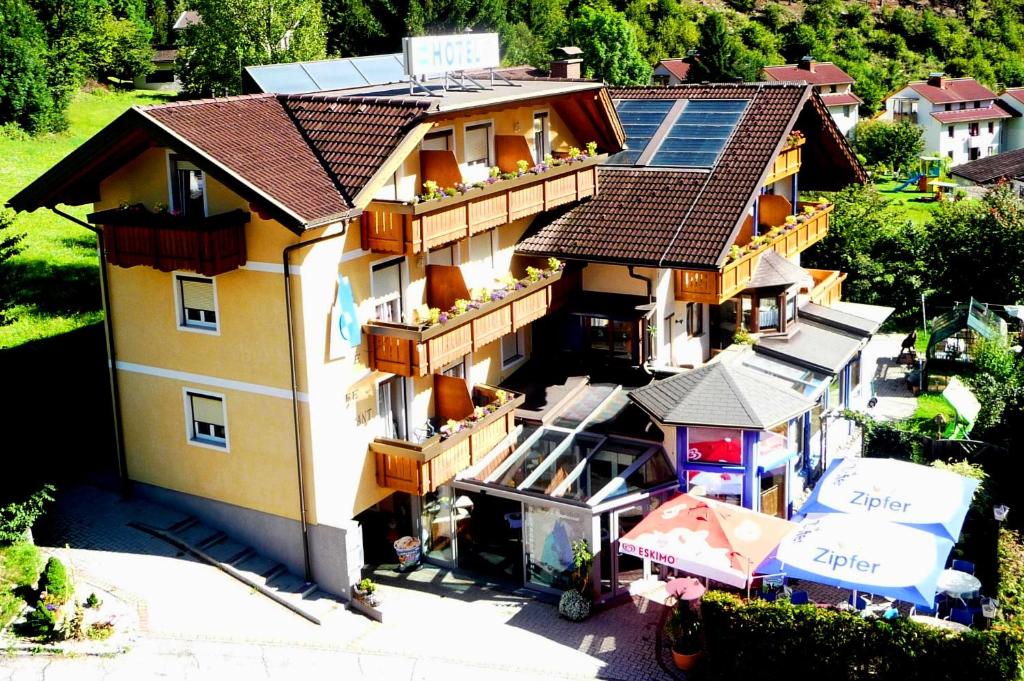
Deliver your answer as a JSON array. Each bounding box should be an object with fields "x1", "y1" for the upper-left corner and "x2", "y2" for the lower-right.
[{"x1": 175, "y1": 0, "x2": 326, "y2": 96}]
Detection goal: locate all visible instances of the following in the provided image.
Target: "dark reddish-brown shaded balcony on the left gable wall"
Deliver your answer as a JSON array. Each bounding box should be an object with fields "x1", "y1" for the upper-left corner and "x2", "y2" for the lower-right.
[{"x1": 88, "y1": 206, "x2": 249, "y2": 276}]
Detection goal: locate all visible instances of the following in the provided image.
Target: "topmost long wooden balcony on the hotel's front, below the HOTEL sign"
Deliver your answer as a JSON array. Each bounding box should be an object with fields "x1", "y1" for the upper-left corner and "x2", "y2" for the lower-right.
[{"x1": 360, "y1": 155, "x2": 606, "y2": 255}]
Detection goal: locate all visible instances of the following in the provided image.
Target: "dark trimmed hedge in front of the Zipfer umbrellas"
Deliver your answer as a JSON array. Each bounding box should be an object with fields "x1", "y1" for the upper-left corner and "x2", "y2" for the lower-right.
[{"x1": 701, "y1": 592, "x2": 1024, "y2": 681}]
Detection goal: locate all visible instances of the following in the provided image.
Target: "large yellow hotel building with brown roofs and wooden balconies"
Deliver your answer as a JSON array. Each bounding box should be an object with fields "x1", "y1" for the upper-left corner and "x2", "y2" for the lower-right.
[{"x1": 9, "y1": 65, "x2": 886, "y2": 600}]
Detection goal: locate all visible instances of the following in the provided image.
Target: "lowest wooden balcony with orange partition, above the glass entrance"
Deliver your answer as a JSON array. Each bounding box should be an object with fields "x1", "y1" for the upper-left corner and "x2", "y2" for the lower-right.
[{"x1": 370, "y1": 382, "x2": 525, "y2": 497}]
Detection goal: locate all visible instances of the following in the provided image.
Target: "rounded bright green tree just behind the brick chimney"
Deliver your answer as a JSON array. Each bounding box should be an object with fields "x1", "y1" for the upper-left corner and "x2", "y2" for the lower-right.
[{"x1": 568, "y1": 5, "x2": 651, "y2": 85}]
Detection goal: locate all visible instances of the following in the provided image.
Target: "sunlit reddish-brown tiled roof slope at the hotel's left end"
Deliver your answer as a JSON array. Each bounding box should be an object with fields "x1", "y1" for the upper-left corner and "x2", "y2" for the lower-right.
[{"x1": 142, "y1": 95, "x2": 352, "y2": 223}]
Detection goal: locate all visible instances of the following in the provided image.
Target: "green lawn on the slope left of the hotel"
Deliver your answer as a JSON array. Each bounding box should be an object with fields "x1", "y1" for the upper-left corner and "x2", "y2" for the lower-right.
[{"x1": 0, "y1": 88, "x2": 174, "y2": 348}]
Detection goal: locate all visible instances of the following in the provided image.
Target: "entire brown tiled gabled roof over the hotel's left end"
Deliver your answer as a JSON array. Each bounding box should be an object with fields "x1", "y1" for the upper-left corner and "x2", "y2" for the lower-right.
[{"x1": 9, "y1": 94, "x2": 425, "y2": 231}]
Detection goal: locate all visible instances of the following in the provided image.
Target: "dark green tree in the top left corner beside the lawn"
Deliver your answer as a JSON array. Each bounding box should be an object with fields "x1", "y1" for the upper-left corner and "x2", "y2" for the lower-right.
[{"x1": 0, "y1": 0, "x2": 61, "y2": 133}]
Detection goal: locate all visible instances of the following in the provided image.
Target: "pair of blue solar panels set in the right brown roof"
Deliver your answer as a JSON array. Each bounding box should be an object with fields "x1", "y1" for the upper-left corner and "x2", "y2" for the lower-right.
[{"x1": 608, "y1": 99, "x2": 746, "y2": 168}]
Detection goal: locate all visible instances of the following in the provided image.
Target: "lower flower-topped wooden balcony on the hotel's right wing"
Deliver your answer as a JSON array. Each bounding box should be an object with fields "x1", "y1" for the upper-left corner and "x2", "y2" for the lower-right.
[{"x1": 676, "y1": 204, "x2": 833, "y2": 305}]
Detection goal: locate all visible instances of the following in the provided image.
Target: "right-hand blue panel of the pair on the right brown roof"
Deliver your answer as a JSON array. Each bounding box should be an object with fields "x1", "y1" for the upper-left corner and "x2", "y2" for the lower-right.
[{"x1": 647, "y1": 99, "x2": 746, "y2": 168}]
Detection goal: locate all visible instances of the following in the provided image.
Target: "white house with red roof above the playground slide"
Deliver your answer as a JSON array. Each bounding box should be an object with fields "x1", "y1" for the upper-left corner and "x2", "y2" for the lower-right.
[{"x1": 876, "y1": 74, "x2": 1015, "y2": 165}]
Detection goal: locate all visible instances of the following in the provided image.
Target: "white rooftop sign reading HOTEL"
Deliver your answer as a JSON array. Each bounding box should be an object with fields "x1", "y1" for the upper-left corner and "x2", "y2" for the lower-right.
[{"x1": 401, "y1": 33, "x2": 501, "y2": 78}]
